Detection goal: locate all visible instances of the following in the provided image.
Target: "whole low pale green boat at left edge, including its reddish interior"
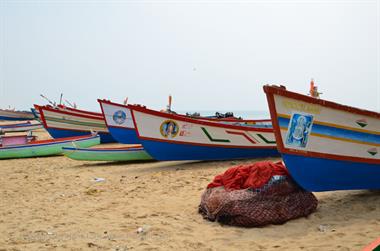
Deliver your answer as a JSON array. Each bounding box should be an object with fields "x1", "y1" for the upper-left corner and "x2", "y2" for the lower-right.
[{"x1": 0, "y1": 135, "x2": 100, "y2": 159}]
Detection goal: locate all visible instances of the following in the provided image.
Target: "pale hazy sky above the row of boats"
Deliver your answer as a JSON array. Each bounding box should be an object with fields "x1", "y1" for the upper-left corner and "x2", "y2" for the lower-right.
[{"x1": 0, "y1": 0, "x2": 380, "y2": 111}]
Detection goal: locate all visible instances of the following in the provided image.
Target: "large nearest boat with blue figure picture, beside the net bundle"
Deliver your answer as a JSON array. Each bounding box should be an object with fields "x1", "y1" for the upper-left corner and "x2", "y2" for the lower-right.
[{"x1": 264, "y1": 86, "x2": 380, "y2": 191}]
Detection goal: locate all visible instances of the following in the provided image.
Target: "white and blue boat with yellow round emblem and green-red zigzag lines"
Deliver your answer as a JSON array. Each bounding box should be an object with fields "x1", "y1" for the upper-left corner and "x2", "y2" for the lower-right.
[{"x1": 129, "y1": 105, "x2": 279, "y2": 160}]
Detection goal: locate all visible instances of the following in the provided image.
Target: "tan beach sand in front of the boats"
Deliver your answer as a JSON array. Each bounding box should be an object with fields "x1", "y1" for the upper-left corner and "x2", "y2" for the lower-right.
[{"x1": 0, "y1": 132, "x2": 380, "y2": 251}]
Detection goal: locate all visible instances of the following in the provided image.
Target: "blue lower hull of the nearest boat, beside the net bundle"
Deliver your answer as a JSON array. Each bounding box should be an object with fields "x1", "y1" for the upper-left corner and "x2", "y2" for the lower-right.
[{"x1": 282, "y1": 154, "x2": 380, "y2": 192}]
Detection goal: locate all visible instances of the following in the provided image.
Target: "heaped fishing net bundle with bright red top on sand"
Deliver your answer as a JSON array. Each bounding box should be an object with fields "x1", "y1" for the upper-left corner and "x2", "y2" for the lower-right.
[{"x1": 199, "y1": 161, "x2": 318, "y2": 227}]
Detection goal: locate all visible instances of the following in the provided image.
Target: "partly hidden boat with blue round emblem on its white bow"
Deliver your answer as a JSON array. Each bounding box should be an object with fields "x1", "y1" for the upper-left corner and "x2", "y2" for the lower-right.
[{"x1": 98, "y1": 99, "x2": 272, "y2": 144}]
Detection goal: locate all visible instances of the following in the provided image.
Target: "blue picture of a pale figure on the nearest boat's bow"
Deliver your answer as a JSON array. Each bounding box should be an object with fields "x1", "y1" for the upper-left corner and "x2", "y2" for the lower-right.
[{"x1": 286, "y1": 113, "x2": 313, "y2": 148}]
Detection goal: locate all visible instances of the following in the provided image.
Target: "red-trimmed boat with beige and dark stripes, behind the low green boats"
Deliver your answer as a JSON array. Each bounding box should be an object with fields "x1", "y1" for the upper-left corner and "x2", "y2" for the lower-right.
[{"x1": 35, "y1": 105, "x2": 115, "y2": 143}]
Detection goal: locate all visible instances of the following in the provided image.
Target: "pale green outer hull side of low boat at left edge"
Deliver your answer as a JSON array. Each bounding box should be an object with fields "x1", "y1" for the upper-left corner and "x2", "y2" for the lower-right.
[{"x1": 0, "y1": 136, "x2": 100, "y2": 159}]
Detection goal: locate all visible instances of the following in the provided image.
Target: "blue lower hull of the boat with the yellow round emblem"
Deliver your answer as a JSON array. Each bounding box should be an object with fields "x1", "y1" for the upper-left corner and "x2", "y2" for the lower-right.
[{"x1": 141, "y1": 140, "x2": 280, "y2": 160}]
